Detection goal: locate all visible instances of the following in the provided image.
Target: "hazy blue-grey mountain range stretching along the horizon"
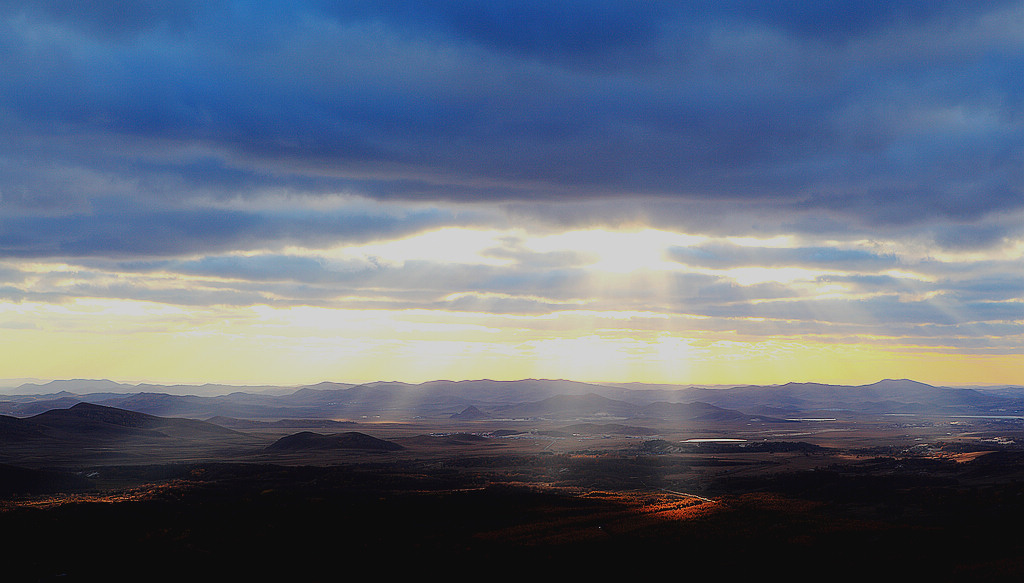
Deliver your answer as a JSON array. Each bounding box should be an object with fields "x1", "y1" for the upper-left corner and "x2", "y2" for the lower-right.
[{"x1": 0, "y1": 379, "x2": 1024, "y2": 420}]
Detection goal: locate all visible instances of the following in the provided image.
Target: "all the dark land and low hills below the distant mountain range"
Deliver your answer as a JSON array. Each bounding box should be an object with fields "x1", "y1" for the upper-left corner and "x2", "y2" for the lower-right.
[{"x1": 6, "y1": 379, "x2": 1024, "y2": 581}]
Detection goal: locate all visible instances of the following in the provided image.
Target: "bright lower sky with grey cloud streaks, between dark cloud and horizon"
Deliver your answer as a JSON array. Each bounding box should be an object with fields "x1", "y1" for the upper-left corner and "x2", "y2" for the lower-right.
[{"x1": 0, "y1": 218, "x2": 1024, "y2": 384}]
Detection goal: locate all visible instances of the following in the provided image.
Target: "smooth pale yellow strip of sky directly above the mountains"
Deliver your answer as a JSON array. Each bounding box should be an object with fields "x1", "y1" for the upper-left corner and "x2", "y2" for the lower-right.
[{"x1": 0, "y1": 297, "x2": 1024, "y2": 385}]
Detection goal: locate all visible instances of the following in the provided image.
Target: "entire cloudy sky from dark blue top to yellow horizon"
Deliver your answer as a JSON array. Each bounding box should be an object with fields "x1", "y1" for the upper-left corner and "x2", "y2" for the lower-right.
[{"x1": 0, "y1": 0, "x2": 1024, "y2": 384}]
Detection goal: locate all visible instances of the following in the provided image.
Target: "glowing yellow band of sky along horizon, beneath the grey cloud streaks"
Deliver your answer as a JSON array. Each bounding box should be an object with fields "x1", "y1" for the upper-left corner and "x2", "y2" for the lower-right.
[{"x1": 0, "y1": 290, "x2": 1024, "y2": 384}]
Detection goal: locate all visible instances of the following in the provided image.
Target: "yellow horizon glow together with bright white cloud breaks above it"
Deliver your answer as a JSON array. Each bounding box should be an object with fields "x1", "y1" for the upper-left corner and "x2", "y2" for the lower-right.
[{"x1": 0, "y1": 228, "x2": 1024, "y2": 385}]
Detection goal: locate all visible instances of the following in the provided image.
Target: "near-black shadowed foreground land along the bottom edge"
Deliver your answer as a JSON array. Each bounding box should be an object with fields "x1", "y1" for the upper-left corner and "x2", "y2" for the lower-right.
[{"x1": 6, "y1": 458, "x2": 1024, "y2": 580}]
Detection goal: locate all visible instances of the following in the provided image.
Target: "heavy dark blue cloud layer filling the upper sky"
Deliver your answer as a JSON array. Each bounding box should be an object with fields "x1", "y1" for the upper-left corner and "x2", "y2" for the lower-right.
[{"x1": 0, "y1": 0, "x2": 1024, "y2": 254}]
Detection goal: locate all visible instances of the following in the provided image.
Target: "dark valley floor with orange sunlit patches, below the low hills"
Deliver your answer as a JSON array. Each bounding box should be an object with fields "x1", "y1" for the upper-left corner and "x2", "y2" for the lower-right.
[{"x1": 6, "y1": 434, "x2": 1024, "y2": 581}]
